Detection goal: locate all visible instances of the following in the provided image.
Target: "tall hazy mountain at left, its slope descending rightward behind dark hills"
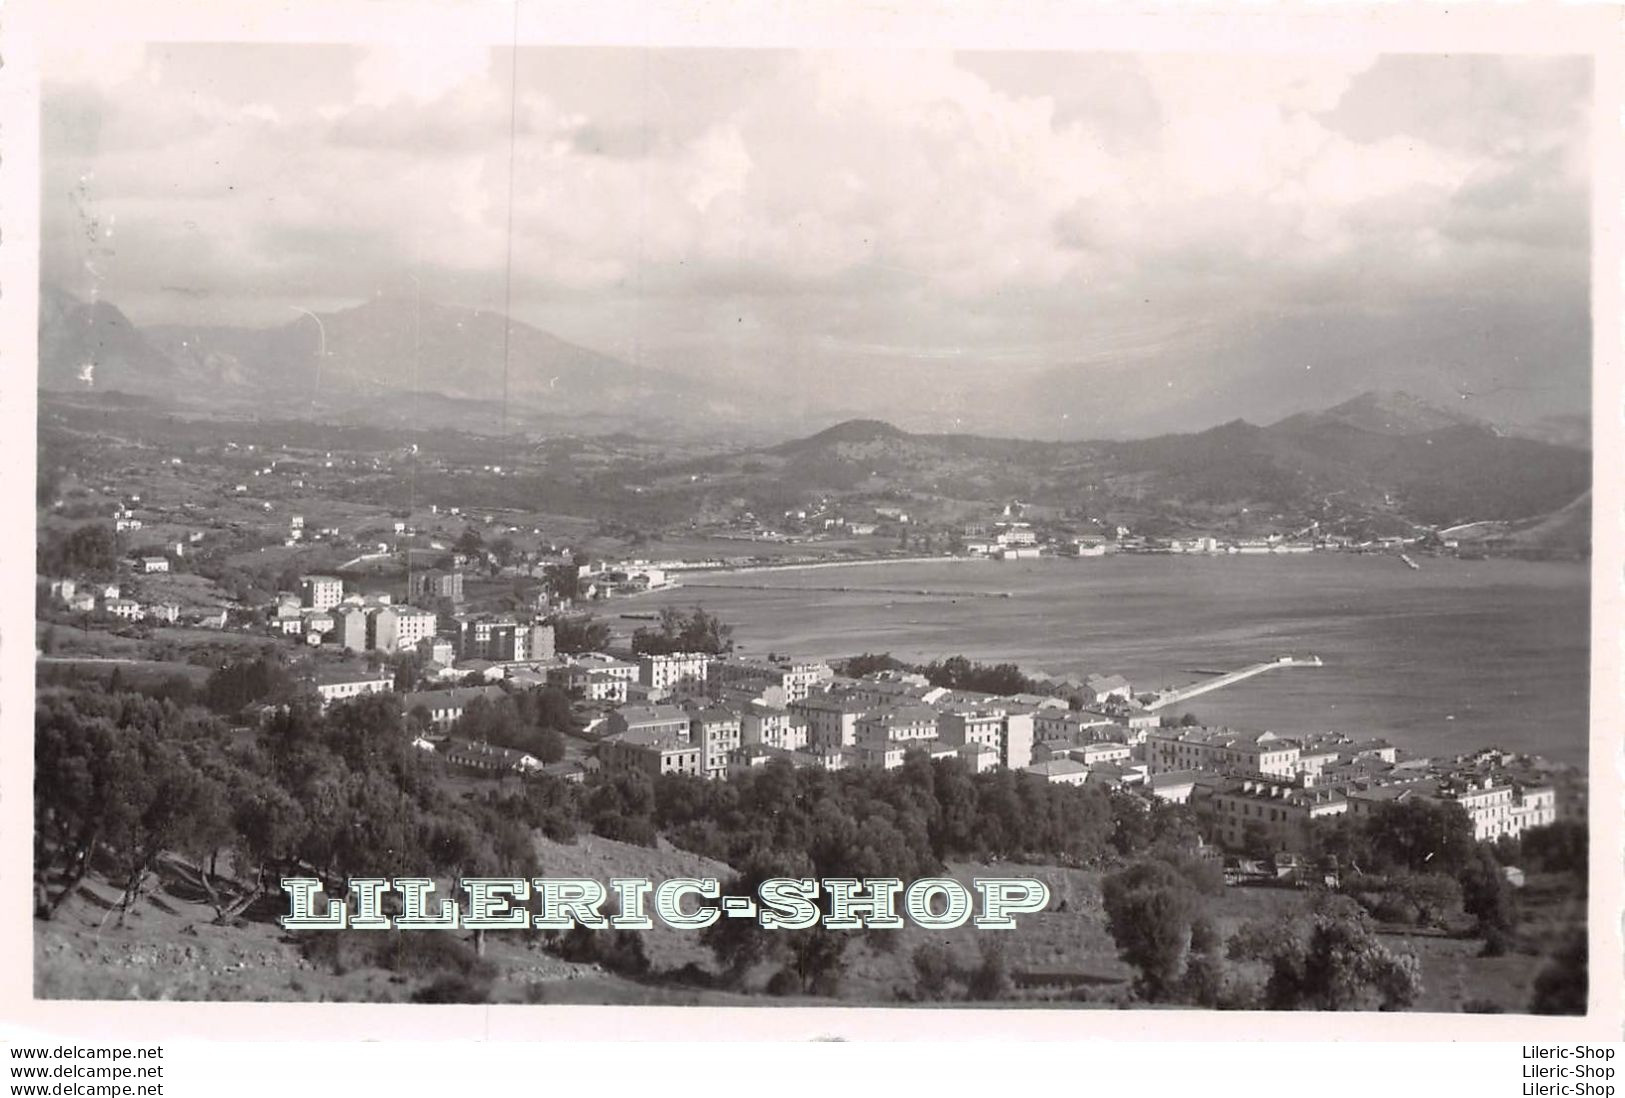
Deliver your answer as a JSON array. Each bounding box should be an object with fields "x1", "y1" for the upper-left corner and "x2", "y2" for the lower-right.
[{"x1": 39, "y1": 286, "x2": 760, "y2": 432}]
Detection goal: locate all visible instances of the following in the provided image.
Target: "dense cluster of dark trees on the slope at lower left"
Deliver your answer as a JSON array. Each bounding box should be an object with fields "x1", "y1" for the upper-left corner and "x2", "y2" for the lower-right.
[{"x1": 34, "y1": 689, "x2": 535, "y2": 942}]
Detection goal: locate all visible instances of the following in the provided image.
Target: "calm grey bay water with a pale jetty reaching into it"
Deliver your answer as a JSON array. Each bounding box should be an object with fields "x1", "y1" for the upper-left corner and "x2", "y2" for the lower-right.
[{"x1": 633, "y1": 554, "x2": 1591, "y2": 765}]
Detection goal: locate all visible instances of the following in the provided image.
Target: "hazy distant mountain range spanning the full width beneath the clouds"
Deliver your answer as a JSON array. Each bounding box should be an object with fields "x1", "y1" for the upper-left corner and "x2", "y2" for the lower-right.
[{"x1": 39, "y1": 286, "x2": 1589, "y2": 447}]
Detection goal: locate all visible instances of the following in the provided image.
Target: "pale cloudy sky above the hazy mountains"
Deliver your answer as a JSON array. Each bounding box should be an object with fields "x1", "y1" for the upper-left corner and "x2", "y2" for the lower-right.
[{"x1": 42, "y1": 41, "x2": 1591, "y2": 434}]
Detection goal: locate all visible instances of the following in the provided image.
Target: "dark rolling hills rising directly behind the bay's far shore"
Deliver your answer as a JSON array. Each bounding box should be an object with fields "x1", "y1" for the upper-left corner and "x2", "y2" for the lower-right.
[{"x1": 666, "y1": 393, "x2": 1591, "y2": 525}]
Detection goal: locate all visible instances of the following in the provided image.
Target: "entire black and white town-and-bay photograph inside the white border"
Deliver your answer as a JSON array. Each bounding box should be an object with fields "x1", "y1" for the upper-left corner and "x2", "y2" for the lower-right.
[{"x1": 19, "y1": 3, "x2": 1619, "y2": 1026}]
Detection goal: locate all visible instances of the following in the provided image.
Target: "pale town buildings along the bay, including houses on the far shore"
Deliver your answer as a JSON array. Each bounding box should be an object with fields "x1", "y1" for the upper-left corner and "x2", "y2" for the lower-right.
[{"x1": 42, "y1": 493, "x2": 1558, "y2": 851}]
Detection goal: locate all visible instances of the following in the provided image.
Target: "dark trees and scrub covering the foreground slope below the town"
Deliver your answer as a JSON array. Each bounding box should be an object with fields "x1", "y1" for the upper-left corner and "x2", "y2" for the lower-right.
[{"x1": 34, "y1": 664, "x2": 1586, "y2": 1012}]
